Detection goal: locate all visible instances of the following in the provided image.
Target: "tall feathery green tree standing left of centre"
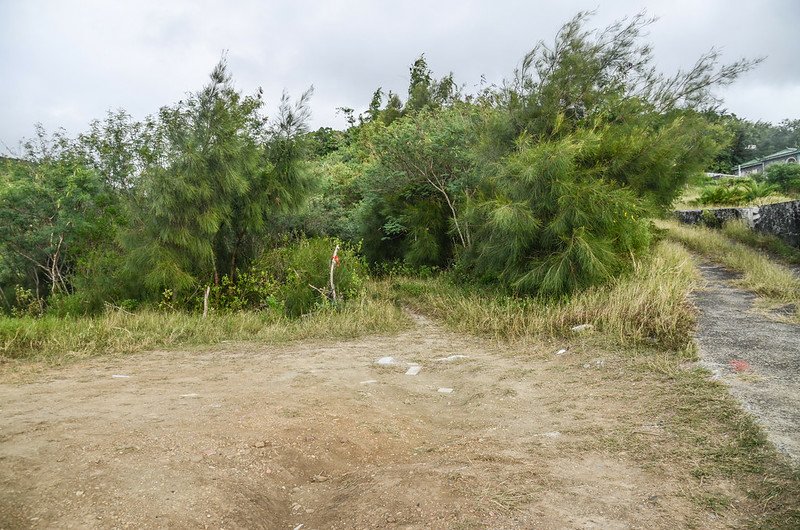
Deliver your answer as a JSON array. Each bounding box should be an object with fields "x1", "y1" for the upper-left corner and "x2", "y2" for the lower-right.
[{"x1": 124, "y1": 60, "x2": 310, "y2": 294}]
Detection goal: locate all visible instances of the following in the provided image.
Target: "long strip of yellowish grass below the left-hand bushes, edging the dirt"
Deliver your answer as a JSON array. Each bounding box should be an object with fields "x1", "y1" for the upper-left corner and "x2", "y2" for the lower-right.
[{"x1": 0, "y1": 296, "x2": 410, "y2": 363}]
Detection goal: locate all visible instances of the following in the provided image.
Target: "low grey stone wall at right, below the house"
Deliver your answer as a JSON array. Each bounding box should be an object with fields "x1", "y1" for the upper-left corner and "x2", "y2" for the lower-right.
[{"x1": 675, "y1": 201, "x2": 800, "y2": 248}]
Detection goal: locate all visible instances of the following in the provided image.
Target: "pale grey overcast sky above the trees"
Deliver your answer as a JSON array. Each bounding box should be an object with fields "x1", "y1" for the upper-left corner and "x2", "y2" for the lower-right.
[{"x1": 0, "y1": 0, "x2": 800, "y2": 151}]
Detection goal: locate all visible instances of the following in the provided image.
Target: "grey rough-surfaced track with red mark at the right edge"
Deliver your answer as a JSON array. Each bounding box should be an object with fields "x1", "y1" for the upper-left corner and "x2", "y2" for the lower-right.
[{"x1": 695, "y1": 264, "x2": 800, "y2": 463}]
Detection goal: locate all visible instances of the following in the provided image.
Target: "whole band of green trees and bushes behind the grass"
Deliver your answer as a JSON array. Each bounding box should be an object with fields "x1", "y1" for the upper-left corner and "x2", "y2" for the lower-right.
[{"x1": 0, "y1": 13, "x2": 757, "y2": 314}]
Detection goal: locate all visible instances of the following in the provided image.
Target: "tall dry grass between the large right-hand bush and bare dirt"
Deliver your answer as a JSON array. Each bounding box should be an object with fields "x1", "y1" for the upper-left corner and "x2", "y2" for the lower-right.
[{"x1": 391, "y1": 242, "x2": 696, "y2": 349}]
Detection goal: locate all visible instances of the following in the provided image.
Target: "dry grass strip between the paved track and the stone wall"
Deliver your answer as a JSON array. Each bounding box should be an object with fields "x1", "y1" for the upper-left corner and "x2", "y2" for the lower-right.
[{"x1": 658, "y1": 217, "x2": 800, "y2": 303}]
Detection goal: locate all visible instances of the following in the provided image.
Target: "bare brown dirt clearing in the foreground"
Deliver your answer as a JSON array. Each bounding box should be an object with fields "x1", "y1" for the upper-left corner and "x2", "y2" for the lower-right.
[{"x1": 0, "y1": 317, "x2": 735, "y2": 530}]
